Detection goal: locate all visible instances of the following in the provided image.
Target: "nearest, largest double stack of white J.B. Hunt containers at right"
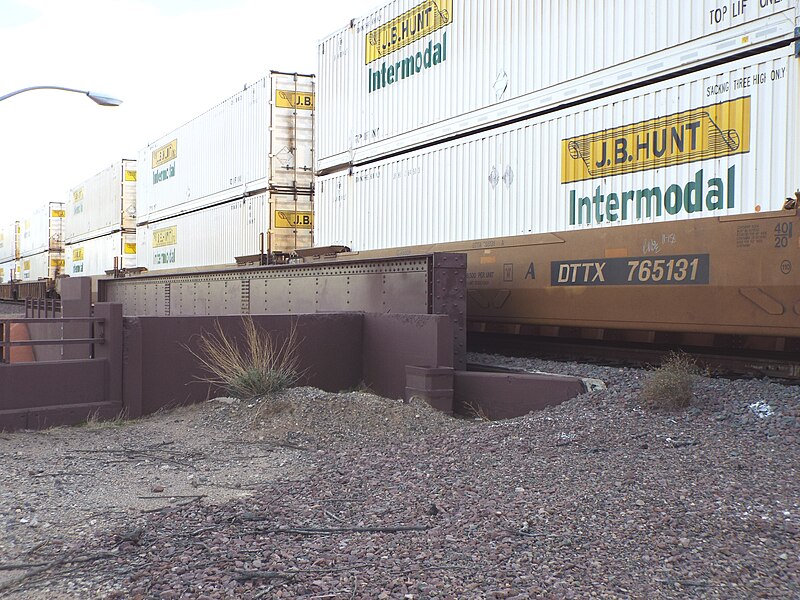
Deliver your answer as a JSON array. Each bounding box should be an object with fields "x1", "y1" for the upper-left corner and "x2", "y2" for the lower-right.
[{"x1": 316, "y1": 0, "x2": 800, "y2": 250}]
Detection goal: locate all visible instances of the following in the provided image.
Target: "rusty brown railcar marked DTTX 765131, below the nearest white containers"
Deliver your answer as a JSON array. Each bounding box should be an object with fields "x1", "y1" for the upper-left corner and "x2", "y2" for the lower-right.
[{"x1": 322, "y1": 208, "x2": 800, "y2": 351}]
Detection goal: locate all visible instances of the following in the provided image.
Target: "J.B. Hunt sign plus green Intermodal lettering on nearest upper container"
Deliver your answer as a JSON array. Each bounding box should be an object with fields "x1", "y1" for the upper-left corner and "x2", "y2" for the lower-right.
[{"x1": 364, "y1": 0, "x2": 453, "y2": 93}]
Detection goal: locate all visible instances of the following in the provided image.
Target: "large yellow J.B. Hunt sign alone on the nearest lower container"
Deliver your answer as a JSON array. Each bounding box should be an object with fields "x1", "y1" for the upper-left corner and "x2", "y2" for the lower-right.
[{"x1": 561, "y1": 96, "x2": 750, "y2": 183}]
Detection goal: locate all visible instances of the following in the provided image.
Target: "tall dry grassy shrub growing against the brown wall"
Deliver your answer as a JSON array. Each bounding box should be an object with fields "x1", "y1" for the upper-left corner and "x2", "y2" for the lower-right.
[{"x1": 190, "y1": 315, "x2": 301, "y2": 400}]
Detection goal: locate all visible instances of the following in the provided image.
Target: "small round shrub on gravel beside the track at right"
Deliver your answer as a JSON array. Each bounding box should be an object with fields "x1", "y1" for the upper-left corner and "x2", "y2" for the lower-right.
[{"x1": 642, "y1": 352, "x2": 700, "y2": 410}]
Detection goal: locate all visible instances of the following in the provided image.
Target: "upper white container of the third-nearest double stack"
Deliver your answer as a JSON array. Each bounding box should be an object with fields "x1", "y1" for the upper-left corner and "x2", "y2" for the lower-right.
[{"x1": 69, "y1": 159, "x2": 136, "y2": 243}]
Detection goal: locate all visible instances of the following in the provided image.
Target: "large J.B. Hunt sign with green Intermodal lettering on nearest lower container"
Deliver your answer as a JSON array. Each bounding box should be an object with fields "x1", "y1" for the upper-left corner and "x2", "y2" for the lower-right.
[{"x1": 561, "y1": 96, "x2": 750, "y2": 225}]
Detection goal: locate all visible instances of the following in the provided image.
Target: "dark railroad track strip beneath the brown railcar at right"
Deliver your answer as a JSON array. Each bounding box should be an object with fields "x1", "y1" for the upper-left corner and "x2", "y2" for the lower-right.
[{"x1": 467, "y1": 332, "x2": 800, "y2": 385}]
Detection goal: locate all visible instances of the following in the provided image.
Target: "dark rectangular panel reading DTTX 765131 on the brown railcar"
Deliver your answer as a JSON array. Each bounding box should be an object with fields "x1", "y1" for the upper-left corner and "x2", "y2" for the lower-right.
[{"x1": 550, "y1": 254, "x2": 710, "y2": 287}]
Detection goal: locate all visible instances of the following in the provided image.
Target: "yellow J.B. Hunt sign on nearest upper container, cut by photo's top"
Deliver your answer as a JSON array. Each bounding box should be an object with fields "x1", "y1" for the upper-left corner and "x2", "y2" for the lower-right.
[{"x1": 364, "y1": 0, "x2": 453, "y2": 65}]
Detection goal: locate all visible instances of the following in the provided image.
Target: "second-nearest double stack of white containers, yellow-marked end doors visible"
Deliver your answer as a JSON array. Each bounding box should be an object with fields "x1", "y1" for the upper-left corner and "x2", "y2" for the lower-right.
[{"x1": 137, "y1": 71, "x2": 314, "y2": 270}]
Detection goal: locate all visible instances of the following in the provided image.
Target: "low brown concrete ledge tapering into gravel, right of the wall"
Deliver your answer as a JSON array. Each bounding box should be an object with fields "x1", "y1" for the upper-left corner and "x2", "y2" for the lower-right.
[{"x1": 454, "y1": 371, "x2": 586, "y2": 421}]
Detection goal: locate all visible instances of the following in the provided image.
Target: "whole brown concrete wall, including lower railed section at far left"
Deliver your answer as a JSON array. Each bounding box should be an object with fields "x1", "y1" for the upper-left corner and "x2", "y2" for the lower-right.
[{"x1": 0, "y1": 303, "x2": 453, "y2": 430}]
